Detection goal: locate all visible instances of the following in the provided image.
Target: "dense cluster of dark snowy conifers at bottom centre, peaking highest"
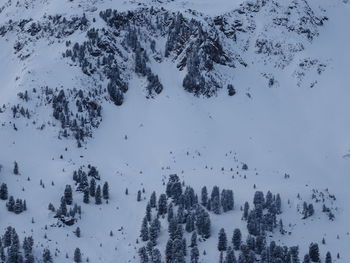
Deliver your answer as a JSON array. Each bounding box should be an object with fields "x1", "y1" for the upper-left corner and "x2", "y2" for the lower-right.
[{"x1": 139, "y1": 174, "x2": 211, "y2": 263}]
